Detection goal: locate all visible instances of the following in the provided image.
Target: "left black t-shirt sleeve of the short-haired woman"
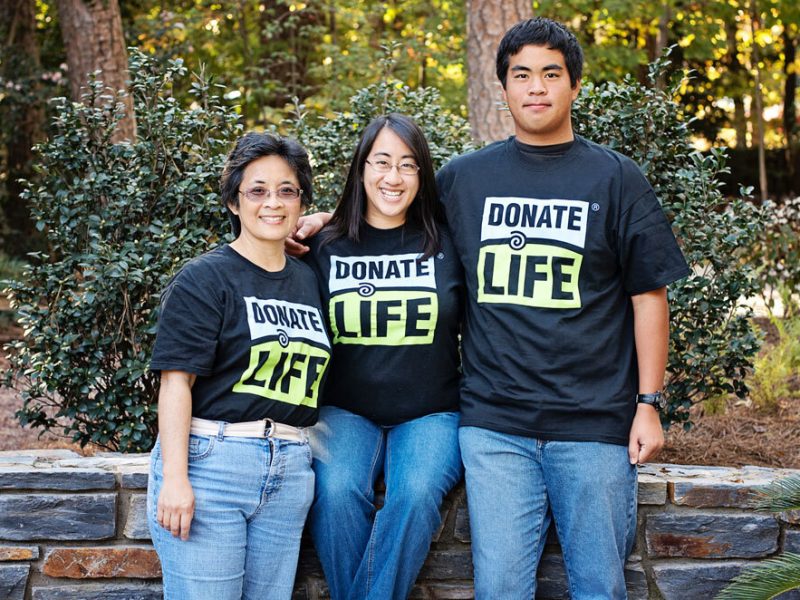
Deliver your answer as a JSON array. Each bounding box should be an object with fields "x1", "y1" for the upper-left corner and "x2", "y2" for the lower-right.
[{"x1": 150, "y1": 270, "x2": 223, "y2": 376}]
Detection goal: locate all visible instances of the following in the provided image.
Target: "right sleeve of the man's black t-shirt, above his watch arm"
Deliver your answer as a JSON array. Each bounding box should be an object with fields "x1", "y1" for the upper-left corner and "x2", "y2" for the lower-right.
[{"x1": 617, "y1": 186, "x2": 690, "y2": 296}]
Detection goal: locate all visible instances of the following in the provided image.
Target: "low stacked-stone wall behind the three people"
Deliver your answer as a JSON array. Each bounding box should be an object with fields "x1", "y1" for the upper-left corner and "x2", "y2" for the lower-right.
[{"x1": 0, "y1": 450, "x2": 800, "y2": 600}]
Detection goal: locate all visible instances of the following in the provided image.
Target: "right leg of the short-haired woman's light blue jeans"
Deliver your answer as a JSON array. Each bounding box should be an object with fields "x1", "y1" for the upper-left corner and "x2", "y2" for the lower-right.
[{"x1": 242, "y1": 439, "x2": 314, "y2": 600}]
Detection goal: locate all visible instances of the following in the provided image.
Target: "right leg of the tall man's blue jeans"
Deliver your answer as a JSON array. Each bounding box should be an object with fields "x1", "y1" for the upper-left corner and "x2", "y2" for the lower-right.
[{"x1": 542, "y1": 441, "x2": 636, "y2": 600}]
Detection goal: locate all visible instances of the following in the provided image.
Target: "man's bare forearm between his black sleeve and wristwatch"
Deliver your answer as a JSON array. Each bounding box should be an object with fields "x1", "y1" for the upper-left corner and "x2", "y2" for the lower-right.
[{"x1": 631, "y1": 287, "x2": 669, "y2": 394}]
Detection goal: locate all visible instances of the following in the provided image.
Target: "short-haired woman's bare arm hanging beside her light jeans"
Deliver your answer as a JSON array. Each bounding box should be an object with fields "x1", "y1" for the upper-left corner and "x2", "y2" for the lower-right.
[{"x1": 157, "y1": 371, "x2": 196, "y2": 540}]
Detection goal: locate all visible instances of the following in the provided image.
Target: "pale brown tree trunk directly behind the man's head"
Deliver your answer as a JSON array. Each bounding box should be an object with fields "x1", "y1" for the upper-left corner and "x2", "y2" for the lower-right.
[{"x1": 467, "y1": 0, "x2": 533, "y2": 142}]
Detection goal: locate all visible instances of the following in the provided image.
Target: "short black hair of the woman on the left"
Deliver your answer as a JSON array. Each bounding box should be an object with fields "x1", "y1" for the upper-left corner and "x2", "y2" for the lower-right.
[{"x1": 219, "y1": 132, "x2": 314, "y2": 237}]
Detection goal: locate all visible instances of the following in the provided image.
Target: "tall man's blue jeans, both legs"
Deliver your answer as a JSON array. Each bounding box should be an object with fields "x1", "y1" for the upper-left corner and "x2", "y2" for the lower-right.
[{"x1": 459, "y1": 427, "x2": 636, "y2": 600}]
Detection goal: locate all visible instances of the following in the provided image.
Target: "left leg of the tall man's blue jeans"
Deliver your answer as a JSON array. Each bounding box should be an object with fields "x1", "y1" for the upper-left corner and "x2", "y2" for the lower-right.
[{"x1": 459, "y1": 427, "x2": 550, "y2": 600}]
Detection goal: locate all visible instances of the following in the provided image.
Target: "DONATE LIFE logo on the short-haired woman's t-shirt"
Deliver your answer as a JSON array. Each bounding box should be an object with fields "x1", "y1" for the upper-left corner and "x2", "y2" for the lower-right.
[{"x1": 233, "y1": 296, "x2": 331, "y2": 408}]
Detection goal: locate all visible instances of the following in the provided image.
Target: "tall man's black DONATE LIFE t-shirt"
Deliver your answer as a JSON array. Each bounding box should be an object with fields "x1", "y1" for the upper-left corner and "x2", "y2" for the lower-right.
[{"x1": 437, "y1": 137, "x2": 689, "y2": 444}]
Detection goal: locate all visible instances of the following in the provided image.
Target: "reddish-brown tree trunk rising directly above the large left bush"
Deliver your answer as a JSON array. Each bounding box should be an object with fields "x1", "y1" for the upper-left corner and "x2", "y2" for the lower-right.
[{"x1": 58, "y1": 0, "x2": 136, "y2": 141}]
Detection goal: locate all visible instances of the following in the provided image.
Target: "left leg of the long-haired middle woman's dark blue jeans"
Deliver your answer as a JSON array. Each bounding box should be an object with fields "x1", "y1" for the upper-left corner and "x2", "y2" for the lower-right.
[{"x1": 308, "y1": 406, "x2": 384, "y2": 600}]
